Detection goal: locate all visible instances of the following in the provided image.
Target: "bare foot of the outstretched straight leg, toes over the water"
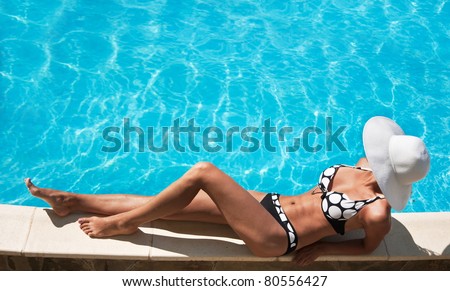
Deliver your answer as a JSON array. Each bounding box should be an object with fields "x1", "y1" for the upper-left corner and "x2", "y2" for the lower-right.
[{"x1": 25, "y1": 178, "x2": 74, "y2": 216}]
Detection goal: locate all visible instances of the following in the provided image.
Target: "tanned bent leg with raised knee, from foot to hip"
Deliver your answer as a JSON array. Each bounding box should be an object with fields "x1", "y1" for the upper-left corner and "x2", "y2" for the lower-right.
[{"x1": 79, "y1": 162, "x2": 287, "y2": 256}]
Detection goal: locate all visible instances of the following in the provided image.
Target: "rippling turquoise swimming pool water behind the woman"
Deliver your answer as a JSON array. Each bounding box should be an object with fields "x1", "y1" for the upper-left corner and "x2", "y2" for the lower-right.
[{"x1": 0, "y1": 0, "x2": 450, "y2": 212}]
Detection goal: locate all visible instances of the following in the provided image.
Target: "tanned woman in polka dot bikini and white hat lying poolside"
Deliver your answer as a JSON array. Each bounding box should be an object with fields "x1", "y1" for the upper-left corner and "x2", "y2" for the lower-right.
[{"x1": 25, "y1": 117, "x2": 429, "y2": 265}]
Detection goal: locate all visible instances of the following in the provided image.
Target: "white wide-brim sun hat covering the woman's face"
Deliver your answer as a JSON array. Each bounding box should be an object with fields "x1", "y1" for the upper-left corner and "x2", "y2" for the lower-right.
[{"x1": 363, "y1": 116, "x2": 430, "y2": 211}]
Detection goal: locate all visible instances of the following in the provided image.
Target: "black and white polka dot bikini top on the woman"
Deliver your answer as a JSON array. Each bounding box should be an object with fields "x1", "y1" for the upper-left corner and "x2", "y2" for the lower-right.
[{"x1": 318, "y1": 165, "x2": 384, "y2": 235}]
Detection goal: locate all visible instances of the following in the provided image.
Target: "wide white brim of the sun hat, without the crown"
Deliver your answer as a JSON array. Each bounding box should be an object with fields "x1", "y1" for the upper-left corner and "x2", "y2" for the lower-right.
[{"x1": 363, "y1": 116, "x2": 411, "y2": 211}]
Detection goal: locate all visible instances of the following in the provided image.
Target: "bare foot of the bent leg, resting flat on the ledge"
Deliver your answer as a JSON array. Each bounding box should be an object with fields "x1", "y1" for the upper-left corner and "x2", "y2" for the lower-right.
[{"x1": 78, "y1": 214, "x2": 138, "y2": 237}]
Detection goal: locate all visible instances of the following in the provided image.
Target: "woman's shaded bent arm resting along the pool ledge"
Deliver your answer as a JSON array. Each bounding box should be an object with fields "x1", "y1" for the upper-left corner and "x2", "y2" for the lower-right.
[{"x1": 292, "y1": 211, "x2": 390, "y2": 266}]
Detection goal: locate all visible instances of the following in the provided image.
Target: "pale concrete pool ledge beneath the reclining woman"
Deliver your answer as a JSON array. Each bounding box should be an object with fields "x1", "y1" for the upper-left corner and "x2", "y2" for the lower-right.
[{"x1": 0, "y1": 205, "x2": 450, "y2": 270}]
